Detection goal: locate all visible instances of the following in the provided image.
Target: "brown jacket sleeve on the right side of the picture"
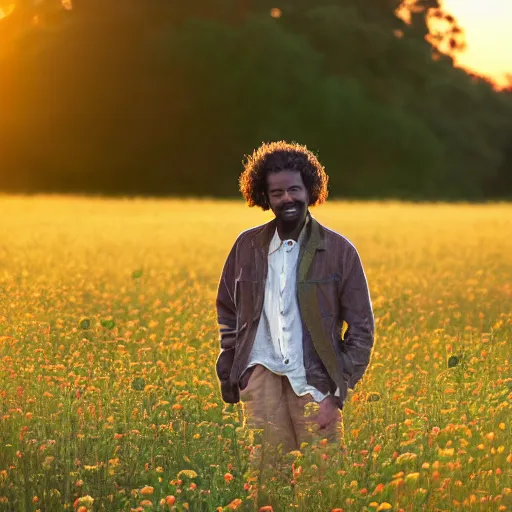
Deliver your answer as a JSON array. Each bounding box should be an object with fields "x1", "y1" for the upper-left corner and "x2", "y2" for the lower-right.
[{"x1": 339, "y1": 245, "x2": 375, "y2": 389}]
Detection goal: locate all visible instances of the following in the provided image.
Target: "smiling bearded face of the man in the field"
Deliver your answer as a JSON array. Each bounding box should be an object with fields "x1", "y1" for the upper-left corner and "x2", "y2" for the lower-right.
[{"x1": 267, "y1": 171, "x2": 309, "y2": 226}]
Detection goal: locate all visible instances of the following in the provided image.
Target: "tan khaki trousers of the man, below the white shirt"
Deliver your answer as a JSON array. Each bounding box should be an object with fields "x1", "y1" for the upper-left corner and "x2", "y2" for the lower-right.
[{"x1": 240, "y1": 365, "x2": 342, "y2": 453}]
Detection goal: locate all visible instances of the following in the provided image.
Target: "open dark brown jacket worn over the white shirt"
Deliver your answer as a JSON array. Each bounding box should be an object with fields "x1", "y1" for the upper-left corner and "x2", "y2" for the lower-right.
[{"x1": 216, "y1": 214, "x2": 374, "y2": 409}]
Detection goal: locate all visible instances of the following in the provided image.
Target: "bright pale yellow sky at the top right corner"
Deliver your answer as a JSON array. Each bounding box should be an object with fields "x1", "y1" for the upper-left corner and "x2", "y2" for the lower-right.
[{"x1": 443, "y1": 0, "x2": 512, "y2": 85}]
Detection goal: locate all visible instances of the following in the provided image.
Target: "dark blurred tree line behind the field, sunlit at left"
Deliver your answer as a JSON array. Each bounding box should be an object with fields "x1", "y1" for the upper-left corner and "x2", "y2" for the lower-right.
[{"x1": 0, "y1": 0, "x2": 512, "y2": 200}]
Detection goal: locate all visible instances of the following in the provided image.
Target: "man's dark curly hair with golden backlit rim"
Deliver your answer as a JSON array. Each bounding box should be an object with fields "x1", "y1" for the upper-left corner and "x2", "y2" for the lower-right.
[{"x1": 239, "y1": 141, "x2": 329, "y2": 210}]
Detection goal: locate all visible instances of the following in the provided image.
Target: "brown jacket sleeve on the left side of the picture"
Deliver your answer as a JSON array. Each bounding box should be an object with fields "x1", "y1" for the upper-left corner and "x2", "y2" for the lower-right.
[{"x1": 216, "y1": 241, "x2": 238, "y2": 403}]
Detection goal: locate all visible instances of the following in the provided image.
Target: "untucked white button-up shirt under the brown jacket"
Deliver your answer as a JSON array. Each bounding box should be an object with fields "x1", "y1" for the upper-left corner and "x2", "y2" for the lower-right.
[{"x1": 248, "y1": 224, "x2": 327, "y2": 402}]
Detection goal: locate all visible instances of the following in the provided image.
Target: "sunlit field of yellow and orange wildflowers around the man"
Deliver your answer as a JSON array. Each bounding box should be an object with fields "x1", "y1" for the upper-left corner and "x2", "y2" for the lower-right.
[{"x1": 0, "y1": 196, "x2": 512, "y2": 512}]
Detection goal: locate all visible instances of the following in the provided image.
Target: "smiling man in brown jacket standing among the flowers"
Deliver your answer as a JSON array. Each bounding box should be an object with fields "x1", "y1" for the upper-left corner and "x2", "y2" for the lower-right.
[{"x1": 216, "y1": 142, "x2": 374, "y2": 451}]
